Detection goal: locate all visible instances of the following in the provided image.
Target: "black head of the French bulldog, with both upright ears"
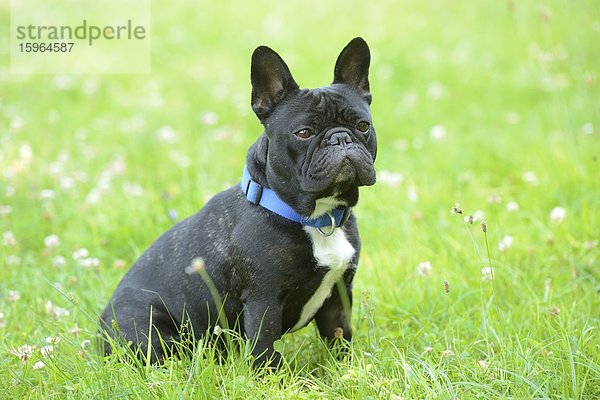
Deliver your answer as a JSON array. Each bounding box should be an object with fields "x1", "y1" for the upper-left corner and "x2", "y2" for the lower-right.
[{"x1": 248, "y1": 38, "x2": 377, "y2": 216}]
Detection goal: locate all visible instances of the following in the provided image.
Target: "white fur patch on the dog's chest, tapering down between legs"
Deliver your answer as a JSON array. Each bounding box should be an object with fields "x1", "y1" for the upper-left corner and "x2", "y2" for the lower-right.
[{"x1": 292, "y1": 227, "x2": 355, "y2": 331}]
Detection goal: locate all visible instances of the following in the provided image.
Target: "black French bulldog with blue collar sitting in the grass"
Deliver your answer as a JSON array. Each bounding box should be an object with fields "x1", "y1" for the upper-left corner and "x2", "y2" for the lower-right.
[{"x1": 100, "y1": 38, "x2": 377, "y2": 365}]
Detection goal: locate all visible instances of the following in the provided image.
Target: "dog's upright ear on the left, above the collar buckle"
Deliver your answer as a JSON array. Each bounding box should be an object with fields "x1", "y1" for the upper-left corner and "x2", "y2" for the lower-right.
[{"x1": 250, "y1": 46, "x2": 298, "y2": 121}]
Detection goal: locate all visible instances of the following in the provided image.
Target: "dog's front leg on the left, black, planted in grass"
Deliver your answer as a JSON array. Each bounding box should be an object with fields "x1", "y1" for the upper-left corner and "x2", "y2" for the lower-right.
[{"x1": 244, "y1": 295, "x2": 282, "y2": 368}]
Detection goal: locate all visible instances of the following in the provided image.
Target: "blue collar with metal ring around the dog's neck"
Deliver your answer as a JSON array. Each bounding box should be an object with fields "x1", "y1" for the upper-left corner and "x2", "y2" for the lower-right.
[{"x1": 240, "y1": 167, "x2": 350, "y2": 236}]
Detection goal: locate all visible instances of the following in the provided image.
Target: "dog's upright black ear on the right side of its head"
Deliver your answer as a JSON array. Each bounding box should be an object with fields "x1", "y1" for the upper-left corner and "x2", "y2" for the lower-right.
[{"x1": 333, "y1": 37, "x2": 372, "y2": 104}]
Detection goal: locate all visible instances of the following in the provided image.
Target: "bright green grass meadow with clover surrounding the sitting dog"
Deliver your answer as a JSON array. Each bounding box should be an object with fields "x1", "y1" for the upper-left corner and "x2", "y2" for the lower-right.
[{"x1": 0, "y1": 0, "x2": 600, "y2": 399}]
